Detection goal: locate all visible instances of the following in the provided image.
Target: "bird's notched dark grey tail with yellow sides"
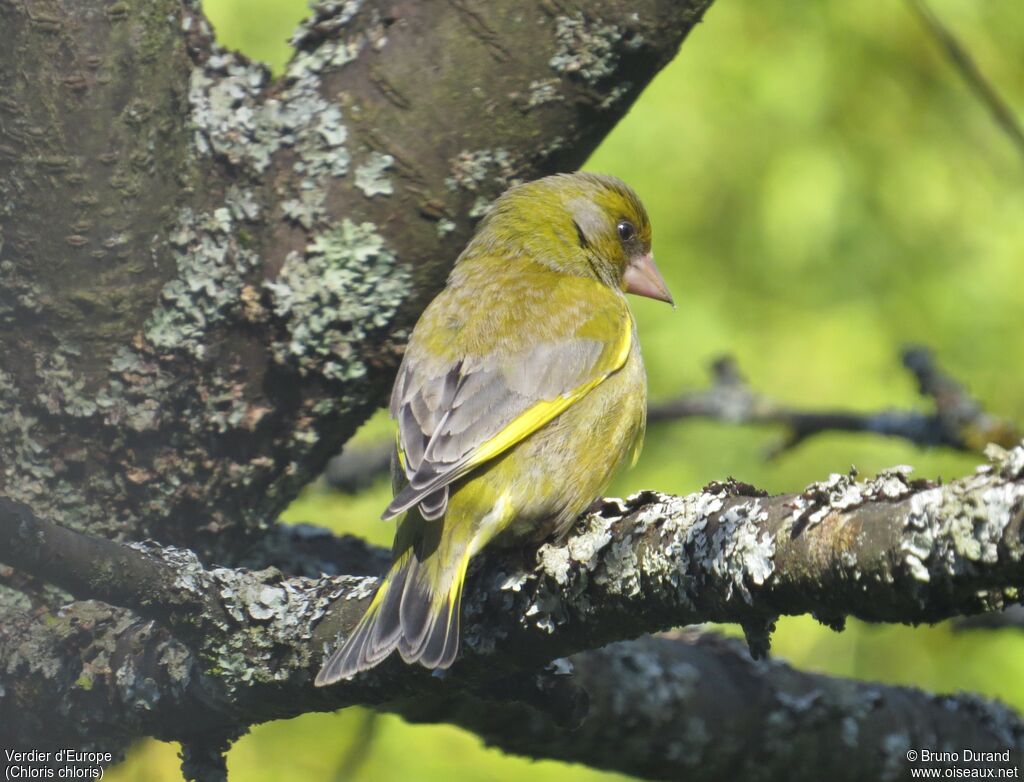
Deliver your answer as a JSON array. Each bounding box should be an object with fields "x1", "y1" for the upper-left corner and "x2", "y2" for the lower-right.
[{"x1": 316, "y1": 548, "x2": 469, "y2": 687}]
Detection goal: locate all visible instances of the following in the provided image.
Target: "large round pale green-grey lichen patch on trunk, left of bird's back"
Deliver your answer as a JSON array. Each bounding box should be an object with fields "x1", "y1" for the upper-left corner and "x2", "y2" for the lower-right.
[{"x1": 265, "y1": 218, "x2": 412, "y2": 380}]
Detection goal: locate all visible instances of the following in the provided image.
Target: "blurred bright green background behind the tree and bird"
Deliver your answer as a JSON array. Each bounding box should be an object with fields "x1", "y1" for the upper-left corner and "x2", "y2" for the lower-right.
[{"x1": 106, "y1": 0, "x2": 1024, "y2": 782}]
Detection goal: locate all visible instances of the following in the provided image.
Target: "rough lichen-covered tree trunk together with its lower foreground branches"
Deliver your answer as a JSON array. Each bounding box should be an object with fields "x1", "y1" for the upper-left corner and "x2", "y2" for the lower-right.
[{"x1": 0, "y1": 0, "x2": 1024, "y2": 779}]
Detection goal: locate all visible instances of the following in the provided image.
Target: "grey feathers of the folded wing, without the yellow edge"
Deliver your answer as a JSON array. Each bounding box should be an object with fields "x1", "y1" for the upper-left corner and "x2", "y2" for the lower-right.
[{"x1": 383, "y1": 339, "x2": 604, "y2": 519}]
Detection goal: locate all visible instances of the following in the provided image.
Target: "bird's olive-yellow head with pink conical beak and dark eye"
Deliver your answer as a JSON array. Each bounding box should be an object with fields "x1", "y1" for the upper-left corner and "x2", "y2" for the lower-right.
[{"x1": 465, "y1": 172, "x2": 674, "y2": 305}]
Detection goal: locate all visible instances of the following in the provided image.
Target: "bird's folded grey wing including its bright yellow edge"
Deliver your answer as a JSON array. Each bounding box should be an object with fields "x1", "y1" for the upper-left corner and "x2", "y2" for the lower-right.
[{"x1": 383, "y1": 295, "x2": 633, "y2": 519}]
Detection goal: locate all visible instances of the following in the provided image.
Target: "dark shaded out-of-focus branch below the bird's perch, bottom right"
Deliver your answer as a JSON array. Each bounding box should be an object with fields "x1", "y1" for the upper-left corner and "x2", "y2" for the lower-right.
[{"x1": 399, "y1": 632, "x2": 1024, "y2": 782}]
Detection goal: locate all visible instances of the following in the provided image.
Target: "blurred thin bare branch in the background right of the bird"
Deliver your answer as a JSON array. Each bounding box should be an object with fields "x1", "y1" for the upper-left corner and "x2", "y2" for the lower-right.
[{"x1": 647, "y1": 347, "x2": 1022, "y2": 453}]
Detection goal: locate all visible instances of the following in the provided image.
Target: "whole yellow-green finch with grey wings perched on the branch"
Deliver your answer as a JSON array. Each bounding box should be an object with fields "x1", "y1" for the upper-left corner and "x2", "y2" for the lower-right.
[{"x1": 316, "y1": 173, "x2": 672, "y2": 686}]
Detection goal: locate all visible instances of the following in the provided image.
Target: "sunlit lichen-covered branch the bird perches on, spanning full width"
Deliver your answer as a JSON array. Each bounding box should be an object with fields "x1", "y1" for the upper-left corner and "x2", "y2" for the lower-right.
[{"x1": 0, "y1": 446, "x2": 1024, "y2": 773}]
